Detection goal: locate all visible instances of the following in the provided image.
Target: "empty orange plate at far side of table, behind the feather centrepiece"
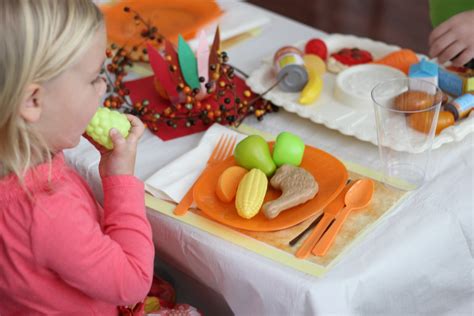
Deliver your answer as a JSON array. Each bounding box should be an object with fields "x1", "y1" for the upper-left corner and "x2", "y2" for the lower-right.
[{"x1": 101, "y1": 0, "x2": 222, "y2": 45}]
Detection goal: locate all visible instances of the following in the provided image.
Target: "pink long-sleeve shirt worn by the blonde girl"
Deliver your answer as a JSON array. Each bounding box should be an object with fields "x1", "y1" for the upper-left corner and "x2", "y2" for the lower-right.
[{"x1": 0, "y1": 153, "x2": 154, "y2": 316}]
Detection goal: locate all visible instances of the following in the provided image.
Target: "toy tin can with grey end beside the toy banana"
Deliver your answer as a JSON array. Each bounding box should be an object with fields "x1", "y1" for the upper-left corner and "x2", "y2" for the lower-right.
[{"x1": 273, "y1": 46, "x2": 308, "y2": 92}]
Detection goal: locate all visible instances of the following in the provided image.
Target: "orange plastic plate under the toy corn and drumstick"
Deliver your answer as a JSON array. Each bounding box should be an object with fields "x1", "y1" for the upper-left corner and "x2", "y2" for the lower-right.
[{"x1": 193, "y1": 145, "x2": 348, "y2": 231}]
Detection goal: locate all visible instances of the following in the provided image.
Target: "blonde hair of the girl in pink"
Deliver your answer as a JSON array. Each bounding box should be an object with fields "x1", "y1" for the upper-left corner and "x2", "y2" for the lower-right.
[{"x1": 0, "y1": 0, "x2": 103, "y2": 179}]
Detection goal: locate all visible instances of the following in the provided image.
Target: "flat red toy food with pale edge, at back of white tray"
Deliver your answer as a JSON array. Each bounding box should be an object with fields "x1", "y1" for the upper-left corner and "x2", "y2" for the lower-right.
[{"x1": 328, "y1": 47, "x2": 373, "y2": 73}]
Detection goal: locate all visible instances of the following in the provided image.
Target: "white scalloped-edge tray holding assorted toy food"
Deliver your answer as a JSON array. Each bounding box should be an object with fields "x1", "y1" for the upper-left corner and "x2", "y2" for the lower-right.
[{"x1": 246, "y1": 34, "x2": 474, "y2": 152}]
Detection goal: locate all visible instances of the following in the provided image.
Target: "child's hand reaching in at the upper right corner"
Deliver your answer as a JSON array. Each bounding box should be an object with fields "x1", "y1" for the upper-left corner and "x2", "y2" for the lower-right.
[{"x1": 429, "y1": 10, "x2": 474, "y2": 67}]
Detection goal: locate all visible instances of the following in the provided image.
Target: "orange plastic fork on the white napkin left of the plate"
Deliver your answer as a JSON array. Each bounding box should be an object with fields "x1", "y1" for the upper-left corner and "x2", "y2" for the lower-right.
[{"x1": 174, "y1": 135, "x2": 237, "y2": 216}]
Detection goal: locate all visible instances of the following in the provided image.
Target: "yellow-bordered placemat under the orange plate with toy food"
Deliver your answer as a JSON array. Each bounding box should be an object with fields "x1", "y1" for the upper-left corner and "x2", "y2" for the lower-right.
[{"x1": 146, "y1": 125, "x2": 406, "y2": 277}]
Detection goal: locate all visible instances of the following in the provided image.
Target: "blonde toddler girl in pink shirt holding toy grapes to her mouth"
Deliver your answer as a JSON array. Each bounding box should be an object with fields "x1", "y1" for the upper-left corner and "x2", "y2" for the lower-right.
[{"x1": 0, "y1": 0, "x2": 154, "y2": 316}]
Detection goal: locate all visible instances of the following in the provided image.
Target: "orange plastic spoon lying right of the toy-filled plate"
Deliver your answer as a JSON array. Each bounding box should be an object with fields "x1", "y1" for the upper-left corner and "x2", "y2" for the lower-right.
[{"x1": 311, "y1": 179, "x2": 374, "y2": 257}]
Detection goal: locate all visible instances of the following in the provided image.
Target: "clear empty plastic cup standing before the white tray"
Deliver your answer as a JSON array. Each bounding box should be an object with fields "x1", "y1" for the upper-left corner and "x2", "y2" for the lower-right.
[{"x1": 371, "y1": 78, "x2": 442, "y2": 191}]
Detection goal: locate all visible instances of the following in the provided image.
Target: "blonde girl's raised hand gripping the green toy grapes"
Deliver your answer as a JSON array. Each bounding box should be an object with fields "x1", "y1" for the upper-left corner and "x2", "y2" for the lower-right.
[{"x1": 94, "y1": 114, "x2": 145, "y2": 178}]
